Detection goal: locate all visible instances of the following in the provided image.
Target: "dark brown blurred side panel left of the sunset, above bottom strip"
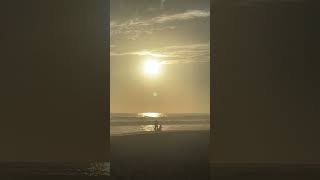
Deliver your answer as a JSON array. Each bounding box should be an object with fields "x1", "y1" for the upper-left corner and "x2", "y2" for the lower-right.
[{"x1": 0, "y1": 0, "x2": 110, "y2": 162}]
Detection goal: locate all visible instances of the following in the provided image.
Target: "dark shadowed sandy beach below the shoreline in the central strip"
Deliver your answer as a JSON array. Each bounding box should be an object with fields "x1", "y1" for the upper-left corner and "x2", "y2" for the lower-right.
[{"x1": 111, "y1": 131, "x2": 210, "y2": 180}]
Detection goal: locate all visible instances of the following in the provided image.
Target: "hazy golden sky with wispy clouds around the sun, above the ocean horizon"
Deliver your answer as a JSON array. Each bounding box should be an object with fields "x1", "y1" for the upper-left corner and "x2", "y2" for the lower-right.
[{"x1": 110, "y1": 0, "x2": 210, "y2": 113}]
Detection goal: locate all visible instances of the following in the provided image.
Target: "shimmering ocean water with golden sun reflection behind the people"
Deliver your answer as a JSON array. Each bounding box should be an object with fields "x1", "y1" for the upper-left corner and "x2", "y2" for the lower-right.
[{"x1": 110, "y1": 112, "x2": 210, "y2": 136}]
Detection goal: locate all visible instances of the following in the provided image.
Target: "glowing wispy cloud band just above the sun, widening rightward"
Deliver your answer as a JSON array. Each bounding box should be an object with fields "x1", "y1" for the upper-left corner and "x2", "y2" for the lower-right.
[{"x1": 110, "y1": 43, "x2": 210, "y2": 64}]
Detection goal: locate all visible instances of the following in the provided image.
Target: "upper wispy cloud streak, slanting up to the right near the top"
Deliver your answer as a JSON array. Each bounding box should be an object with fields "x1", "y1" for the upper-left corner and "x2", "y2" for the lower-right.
[{"x1": 110, "y1": 10, "x2": 210, "y2": 40}]
